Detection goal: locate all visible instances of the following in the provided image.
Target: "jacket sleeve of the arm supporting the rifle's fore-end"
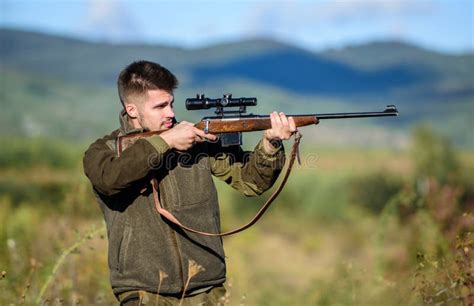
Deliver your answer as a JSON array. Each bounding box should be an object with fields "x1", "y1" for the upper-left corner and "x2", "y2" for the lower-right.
[{"x1": 210, "y1": 141, "x2": 285, "y2": 196}]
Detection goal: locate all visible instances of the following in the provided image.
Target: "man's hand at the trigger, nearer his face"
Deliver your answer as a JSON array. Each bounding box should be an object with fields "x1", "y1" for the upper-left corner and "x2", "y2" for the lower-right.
[{"x1": 160, "y1": 121, "x2": 217, "y2": 151}]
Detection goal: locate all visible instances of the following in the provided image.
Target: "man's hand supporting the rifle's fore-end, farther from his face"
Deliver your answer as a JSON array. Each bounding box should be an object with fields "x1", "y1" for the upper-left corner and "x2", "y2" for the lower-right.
[{"x1": 263, "y1": 112, "x2": 296, "y2": 153}]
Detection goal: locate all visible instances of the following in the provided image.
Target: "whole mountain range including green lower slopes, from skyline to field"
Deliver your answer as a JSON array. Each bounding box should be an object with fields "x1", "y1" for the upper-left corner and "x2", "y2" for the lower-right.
[{"x1": 0, "y1": 29, "x2": 474, "y2": 146}]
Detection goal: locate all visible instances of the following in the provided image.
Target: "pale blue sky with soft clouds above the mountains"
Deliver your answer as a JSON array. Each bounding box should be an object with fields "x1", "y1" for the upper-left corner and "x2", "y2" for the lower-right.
[{"x1": 0, "y1": 0, "x2": 474, "y2": 53}]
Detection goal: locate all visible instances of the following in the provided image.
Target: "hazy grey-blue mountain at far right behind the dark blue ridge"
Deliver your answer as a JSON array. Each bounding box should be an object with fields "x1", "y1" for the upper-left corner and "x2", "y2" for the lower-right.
[{"x1": 320, "y1": 41, "x2": 474, "y2": 100}]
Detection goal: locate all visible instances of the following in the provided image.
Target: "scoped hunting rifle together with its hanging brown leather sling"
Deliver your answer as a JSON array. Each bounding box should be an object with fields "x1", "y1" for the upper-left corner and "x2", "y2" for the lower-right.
[{"x1": 117, "y1": 94, "x2": 398, "y2": 236}]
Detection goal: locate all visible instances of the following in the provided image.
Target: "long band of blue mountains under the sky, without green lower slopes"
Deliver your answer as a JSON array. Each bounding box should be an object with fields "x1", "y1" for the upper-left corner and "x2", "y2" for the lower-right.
[{"x1": 0, "y1": 29, "x2": 474, "y2": 97}]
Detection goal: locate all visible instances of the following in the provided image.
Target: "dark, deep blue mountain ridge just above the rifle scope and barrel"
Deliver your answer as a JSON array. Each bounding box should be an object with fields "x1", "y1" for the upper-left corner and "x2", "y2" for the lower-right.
[{"x1": 191, "y1": 48, "x2": 433, "y2": 96}]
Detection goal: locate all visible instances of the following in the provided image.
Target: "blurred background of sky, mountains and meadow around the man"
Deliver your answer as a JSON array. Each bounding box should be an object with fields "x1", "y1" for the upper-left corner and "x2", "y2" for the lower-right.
[{"x1": 0, "y1": 0, "x2": 474, "y2": 305}]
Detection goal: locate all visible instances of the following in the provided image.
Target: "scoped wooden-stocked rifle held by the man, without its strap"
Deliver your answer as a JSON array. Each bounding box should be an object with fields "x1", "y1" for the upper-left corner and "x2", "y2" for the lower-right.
[{"x1": 118, "y1": 94, "x2": 398, "y2": 152}]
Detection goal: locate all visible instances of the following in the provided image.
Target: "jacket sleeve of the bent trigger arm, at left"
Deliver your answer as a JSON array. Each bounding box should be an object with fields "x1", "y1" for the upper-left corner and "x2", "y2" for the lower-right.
[{"x1": 83, "y1": 135, "x2": 170, "y2": 196}]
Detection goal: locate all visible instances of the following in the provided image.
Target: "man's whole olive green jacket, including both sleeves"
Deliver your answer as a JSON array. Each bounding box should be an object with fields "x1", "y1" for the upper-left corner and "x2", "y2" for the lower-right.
[{"x1": 83, "y1": 113, "x2": 285, "y2": 296}]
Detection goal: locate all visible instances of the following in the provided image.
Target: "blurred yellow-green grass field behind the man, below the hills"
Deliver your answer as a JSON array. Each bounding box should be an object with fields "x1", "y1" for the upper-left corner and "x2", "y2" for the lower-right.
[{"x1": 0, "y1": 137, "x2": 474, "y2": 305}]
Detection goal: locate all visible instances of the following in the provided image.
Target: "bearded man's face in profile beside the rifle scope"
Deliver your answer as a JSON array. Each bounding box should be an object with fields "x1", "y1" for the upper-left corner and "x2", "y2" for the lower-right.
[{"x1": 133, "y1": 89, "x2": 174, "y2": 131}]
